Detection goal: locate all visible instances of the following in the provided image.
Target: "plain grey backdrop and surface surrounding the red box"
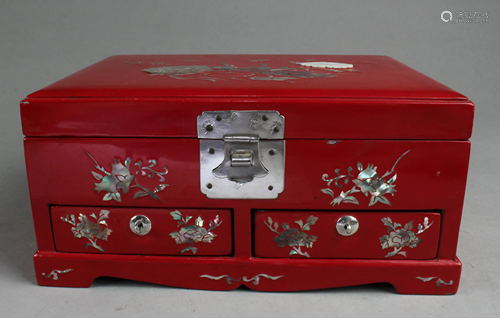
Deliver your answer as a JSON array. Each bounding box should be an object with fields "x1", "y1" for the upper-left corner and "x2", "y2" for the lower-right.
[{"x1": 0, "y1": 0, "x2": 500, "y2": 317}]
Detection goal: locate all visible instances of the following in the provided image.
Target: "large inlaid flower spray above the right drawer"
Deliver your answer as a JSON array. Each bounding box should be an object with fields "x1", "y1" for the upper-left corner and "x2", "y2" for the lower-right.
[{"x1": 321, "y1": 150, "x2": 410, "y2": 206}]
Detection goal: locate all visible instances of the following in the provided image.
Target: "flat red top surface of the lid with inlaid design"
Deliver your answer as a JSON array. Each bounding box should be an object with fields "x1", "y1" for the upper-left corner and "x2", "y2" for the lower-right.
[{"x1": 29, "y1": 55, "x2": 467, "y2": 99}]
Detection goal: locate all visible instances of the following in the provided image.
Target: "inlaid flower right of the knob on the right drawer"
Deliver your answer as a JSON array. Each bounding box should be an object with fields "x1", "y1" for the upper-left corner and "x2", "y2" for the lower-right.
[{"x1": 380, "y1": 217, "x2": 434, "y2": 257}]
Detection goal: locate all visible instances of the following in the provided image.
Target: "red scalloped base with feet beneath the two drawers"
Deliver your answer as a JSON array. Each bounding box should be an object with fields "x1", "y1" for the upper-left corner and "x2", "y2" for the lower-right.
[{"x1": 34, "y1": 251, "x2": 462, "y2": 295}]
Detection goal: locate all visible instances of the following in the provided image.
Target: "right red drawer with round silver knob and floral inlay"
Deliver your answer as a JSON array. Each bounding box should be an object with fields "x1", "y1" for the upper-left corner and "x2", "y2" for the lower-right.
[{"x1": 253, "y1": 211, "x2": 441, "y2": 259}]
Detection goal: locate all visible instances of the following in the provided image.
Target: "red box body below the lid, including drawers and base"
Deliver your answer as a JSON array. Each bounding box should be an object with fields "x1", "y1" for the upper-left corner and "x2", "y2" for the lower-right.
[{"x1": 25, "y1": 138, "x2": 470, "y2": 294}]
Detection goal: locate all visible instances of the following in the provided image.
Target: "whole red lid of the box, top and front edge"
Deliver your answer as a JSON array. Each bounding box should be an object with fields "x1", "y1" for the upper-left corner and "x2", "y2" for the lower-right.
[{"x1": 21, "y1": 55, "x2": 474, "y2": 140}]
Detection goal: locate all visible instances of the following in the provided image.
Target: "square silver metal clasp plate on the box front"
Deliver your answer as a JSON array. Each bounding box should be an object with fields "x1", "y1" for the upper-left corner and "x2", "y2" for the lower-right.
[{"x1": 198, "y1": 111, "x2": 285, "y2": 199}]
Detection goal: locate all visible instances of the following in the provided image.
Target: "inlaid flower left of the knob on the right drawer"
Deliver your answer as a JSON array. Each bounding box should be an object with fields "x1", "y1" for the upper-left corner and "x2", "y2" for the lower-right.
[{"x1": 264, "y1": 215, "x2": 318, "y2": 258}]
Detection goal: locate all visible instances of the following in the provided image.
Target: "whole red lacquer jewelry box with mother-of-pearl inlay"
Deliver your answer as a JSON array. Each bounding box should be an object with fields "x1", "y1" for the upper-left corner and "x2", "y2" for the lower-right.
[{"x1": 21, "y1": 55, "x2": 474, "y2": 294}]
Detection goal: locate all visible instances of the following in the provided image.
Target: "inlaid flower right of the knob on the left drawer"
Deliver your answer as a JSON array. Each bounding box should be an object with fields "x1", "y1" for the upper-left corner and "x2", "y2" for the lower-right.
[{"x1": 170, "y1": 210, "x2": 222, "y2": 254}]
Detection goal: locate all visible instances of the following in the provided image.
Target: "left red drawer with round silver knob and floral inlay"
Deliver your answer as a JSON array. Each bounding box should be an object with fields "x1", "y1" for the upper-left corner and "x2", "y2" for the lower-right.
[{"x1": 50, "y1": 206, "x2": 233, "y2": 256}]
